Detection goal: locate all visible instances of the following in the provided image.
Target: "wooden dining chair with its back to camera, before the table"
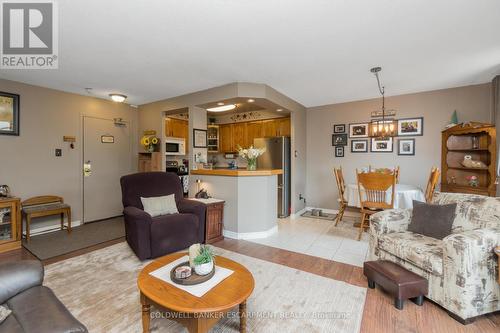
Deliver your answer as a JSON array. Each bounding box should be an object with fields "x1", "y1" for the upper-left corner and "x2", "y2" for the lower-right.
[{"x1": 356, "y1": 170, "x2": 396, "y2": 240}]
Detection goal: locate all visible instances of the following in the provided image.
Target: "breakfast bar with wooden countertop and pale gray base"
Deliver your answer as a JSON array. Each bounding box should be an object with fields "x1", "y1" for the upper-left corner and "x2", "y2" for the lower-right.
[{"x1": 190, "y1": 169, "x2": 283, "y2": 239}]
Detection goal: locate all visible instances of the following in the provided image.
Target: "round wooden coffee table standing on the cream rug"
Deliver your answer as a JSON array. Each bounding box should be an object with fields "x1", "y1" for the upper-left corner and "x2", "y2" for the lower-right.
[{"x1": 137, "y1": 253, "x2": 255, "y2": 332}]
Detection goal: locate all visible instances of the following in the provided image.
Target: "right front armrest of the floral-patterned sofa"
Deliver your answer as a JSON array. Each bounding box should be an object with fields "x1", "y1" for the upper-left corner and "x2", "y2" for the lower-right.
[{"x1": 443, "y1": 228, "x2": 500, "y2": 318}]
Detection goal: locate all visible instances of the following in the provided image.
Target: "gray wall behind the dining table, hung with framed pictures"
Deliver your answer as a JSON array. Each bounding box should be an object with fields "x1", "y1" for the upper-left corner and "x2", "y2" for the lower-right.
[{"x1": 307, "y1": 83, "x2": 491, "y2": 209}]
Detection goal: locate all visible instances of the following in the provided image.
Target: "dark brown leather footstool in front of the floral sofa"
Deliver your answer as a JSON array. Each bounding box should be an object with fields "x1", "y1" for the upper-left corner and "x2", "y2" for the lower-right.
[{"x1": 363, "y1": 260, "x2": 428, "y2": 310}]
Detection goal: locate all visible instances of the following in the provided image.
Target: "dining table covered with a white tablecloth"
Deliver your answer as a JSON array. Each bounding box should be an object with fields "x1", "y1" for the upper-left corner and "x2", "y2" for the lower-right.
[{"x1": 345, "y1": 184, "x2": 425, "y2": 208}]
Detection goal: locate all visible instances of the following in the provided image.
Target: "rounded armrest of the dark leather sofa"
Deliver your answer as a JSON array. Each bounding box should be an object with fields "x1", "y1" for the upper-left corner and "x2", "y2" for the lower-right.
[{"x1": 0, "y1": 260, "x2": 44, "y2": 304}]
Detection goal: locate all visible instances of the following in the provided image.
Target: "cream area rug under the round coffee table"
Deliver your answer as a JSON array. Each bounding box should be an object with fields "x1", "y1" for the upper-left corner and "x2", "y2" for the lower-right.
[{"x1": 45, "y1": 242, "x2": 366, "y2": 333}]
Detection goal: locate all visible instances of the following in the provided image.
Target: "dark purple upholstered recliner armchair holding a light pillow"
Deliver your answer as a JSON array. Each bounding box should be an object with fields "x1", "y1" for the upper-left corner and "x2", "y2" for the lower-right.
[{"x1": 120, "y1": 172, "x2": 206, "y2": 260}]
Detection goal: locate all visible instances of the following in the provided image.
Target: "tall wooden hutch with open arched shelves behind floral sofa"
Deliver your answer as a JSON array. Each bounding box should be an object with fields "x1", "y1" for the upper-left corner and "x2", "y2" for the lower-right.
[{"x1": 441, "y1": 122, "x2": 497, "y2": 197}]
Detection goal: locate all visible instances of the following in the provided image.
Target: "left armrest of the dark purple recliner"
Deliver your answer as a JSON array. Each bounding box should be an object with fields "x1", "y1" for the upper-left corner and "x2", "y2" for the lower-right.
[{"x1": 123, "y1": 206, "x2": 153, "y2": 260}]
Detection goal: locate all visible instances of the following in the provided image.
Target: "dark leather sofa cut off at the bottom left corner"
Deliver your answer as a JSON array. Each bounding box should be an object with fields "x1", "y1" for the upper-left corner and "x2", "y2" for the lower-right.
[{"x1": 0, "y1": 260, "x2": 87, "y2": 333}]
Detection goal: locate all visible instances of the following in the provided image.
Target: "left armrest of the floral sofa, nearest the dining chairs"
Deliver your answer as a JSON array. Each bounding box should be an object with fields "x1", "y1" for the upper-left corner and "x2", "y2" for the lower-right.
[{"x1": 369, "y1": 209, "x2": 412, "y2": 260}]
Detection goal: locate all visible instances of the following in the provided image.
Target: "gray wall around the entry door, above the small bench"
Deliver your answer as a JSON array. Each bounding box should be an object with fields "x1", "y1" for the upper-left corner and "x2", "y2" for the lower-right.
[{"x1": 0, "y1": 80, "x2": 138, "y2": 228}]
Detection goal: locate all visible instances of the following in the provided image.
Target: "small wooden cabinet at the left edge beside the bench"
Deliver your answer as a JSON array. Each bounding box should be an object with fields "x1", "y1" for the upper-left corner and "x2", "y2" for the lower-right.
[{"x1": 0, "y1": 197, "x2": 21, "y2": 253}]
